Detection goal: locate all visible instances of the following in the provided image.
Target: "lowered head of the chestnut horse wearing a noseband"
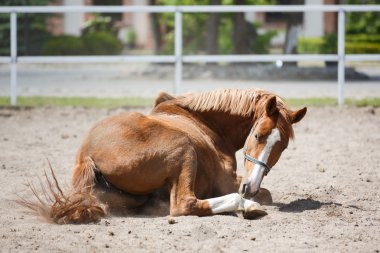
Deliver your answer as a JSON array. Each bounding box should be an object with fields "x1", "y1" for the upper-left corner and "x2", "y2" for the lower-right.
[{"x1": 242, "y1": 96, "x2": 307, "y2": 198}]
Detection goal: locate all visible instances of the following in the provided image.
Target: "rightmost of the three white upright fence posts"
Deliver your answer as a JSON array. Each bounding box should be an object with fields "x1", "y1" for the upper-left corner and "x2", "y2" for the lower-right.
[{"x1": 338, "y1": 9, "x2": 346, "y2": 106}]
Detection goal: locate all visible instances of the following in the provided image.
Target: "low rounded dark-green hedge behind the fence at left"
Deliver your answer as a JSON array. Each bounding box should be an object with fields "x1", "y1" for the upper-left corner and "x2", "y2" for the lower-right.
[{"x1": 43, "y1": 32, "x2": 123, "y2": 55}]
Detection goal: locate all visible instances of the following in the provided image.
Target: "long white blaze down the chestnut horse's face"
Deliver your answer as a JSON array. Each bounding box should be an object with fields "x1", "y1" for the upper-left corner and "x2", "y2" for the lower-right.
[{"x1": 248, "y1": 128, "x2": 281, "y2": 192}]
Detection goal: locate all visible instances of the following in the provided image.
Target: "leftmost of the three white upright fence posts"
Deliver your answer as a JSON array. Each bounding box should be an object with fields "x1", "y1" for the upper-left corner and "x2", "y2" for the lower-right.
[{"x1": 10, "y1": 11, "x2": 17, "y2": 105}]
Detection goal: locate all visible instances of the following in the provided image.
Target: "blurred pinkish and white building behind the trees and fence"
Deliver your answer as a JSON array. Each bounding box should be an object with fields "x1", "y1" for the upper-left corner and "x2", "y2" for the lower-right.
[{"x1": 47, "y1": 0, "x2": 337, "y2": 52}]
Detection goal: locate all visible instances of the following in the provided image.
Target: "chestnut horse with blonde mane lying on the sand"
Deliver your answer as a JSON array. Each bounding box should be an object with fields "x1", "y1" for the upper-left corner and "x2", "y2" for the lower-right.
[{"x1": 23, "y1": 89, "x2": 307, "y2": 224}]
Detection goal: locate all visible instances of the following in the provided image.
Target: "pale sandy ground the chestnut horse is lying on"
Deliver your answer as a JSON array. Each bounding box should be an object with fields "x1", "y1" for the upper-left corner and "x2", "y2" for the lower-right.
[{"x1": 0, "y1": 107, "x2": 380, "y2": 252}]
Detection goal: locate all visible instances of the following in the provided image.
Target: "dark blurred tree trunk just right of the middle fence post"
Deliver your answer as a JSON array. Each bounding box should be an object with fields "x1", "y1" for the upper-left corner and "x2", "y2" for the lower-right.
[{"x1": 206, "y1": 0, "x2": 221, "y2": 54}]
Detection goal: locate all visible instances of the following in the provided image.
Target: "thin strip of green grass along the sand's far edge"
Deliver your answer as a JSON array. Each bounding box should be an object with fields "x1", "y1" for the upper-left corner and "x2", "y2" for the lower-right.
[{"x1": 0, "y1": 97, "x2": 380, "y2": 108}]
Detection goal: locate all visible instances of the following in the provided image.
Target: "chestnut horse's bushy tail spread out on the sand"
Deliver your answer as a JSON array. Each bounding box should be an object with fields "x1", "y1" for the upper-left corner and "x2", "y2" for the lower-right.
[{"x1": 17, "y1": 157, "x2": 107, "y2": 224}]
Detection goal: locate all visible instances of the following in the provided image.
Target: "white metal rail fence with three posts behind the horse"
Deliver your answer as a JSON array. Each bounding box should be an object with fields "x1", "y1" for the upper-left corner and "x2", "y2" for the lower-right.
[{"x1": 0, "y1": 5, "x2": 380, "y2": 105}]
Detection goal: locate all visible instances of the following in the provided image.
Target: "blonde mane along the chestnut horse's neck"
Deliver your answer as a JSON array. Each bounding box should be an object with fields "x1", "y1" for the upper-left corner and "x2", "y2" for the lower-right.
[{"x1": 176, "y1": 89, "x2": 285, "y2": 117}]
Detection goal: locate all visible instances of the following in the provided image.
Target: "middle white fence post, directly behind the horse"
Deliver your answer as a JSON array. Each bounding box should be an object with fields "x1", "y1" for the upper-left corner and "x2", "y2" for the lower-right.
[{"x1": 174, "y1": 8, "x2": 182, "y2": 95}]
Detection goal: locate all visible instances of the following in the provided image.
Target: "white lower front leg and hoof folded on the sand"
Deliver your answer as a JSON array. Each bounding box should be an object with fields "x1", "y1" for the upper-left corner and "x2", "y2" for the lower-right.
[{"x1": 206, "y1": 193, "x2": 267, "y2": 219}]
